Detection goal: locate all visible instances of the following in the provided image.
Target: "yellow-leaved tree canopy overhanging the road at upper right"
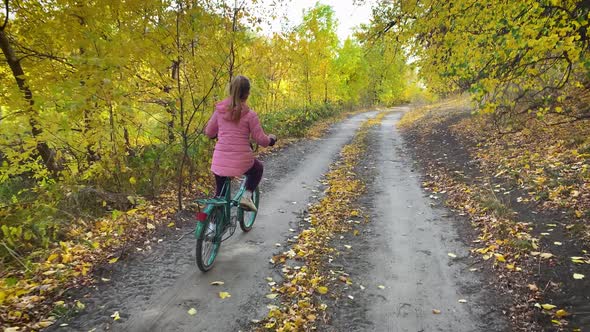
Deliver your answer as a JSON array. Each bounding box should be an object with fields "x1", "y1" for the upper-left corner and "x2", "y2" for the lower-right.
[{"x1": 371, "y1": 0, "x2": 590, "y2": 125}]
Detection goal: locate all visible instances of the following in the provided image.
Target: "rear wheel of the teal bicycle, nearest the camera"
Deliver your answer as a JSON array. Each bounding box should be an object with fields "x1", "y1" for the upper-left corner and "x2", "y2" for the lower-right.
[{"x1": 196, "y1": 207, "x2": 223, "y2": 272}]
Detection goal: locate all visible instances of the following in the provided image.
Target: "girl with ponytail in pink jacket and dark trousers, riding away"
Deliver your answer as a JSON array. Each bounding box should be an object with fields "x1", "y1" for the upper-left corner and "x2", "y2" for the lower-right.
[{"x1": 205, "y1": 75, "x2": 277, "y2": 211}]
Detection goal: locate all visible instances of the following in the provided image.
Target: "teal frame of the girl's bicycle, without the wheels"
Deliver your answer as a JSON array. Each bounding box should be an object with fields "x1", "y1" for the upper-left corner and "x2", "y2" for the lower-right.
[{"x1": 195, "y1": 176, "x2": 247, "y2": 241}]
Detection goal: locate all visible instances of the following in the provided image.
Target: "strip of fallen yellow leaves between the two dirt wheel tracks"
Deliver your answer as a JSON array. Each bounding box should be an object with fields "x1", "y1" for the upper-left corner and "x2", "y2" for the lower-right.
[{"x1": 261, "y1": 112, "x2": 386, "y2": 331}]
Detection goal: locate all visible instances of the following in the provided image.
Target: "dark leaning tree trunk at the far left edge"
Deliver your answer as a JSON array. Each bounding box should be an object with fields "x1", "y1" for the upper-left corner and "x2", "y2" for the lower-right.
[{"x1": 0, "y1": 30, "x2": 58, "y2": 173}]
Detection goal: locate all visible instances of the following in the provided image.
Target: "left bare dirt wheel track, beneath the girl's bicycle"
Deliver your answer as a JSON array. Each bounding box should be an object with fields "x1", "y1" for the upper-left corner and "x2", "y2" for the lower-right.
[{"x1": 56, "y1": 112, "x2": 376, "y2": 331}]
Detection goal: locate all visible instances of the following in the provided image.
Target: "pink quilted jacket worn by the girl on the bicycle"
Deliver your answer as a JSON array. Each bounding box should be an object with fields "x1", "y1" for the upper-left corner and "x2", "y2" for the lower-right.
[{"x1": 205, "y1": 98, "x2": 270, "y2": 176}]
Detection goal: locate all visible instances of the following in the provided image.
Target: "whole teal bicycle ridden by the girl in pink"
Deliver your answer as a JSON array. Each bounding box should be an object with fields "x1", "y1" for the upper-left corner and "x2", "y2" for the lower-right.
[{"x1": 195, "y1": 176, "x2": 260, "y2": 272}]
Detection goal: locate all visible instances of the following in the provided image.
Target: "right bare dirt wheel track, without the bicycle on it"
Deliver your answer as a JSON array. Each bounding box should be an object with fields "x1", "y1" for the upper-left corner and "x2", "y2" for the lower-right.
[{"x1": 326, "y1": 111, "x2": 509, "y2": 332}]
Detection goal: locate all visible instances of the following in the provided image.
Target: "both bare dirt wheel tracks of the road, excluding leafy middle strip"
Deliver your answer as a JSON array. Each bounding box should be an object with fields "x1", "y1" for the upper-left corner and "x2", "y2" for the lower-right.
[{"x1": 53, "y1": 108, "x2": 507, "y2": 331}]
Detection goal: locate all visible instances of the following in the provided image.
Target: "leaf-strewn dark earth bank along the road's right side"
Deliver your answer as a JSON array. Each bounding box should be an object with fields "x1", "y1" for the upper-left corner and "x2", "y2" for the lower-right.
[{"x1": 400, "y1": 97, "x2": 590, "y2": 331}]
